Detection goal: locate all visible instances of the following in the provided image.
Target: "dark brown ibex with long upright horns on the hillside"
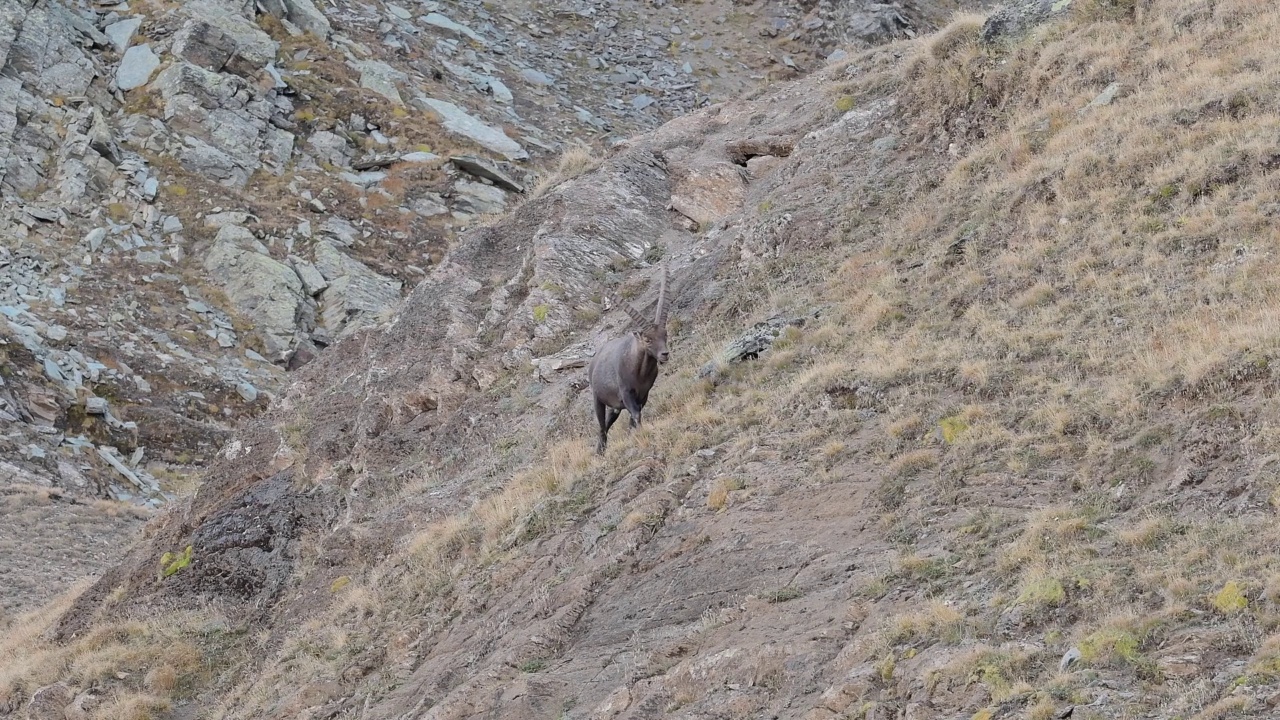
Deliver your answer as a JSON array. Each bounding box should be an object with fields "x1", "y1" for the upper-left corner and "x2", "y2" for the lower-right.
[{"x1": 586, "y1": 265, "x2": 669, "y2": 455}]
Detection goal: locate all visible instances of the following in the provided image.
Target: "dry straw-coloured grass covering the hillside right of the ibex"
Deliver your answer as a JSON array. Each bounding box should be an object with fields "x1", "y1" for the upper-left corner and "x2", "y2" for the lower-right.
[{"x1": 12, "y1": 0, "x2": 1280, "y2": 717}]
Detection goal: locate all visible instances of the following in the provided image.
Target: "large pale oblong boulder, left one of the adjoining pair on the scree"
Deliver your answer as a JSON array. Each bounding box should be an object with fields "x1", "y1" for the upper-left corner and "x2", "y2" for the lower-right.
[{"x1": 204, "y1": 225, "x2": 305, "y2": 361}]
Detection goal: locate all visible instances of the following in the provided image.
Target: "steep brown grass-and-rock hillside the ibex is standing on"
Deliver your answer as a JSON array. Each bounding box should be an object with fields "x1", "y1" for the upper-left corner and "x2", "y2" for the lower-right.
[{"x1": 12, "y1": 0, "x2": 1280, "y2": 720}]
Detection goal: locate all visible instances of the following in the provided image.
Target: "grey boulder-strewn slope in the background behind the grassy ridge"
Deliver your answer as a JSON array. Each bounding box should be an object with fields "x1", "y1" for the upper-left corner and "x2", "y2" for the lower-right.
[{"x1": 0, "y1": 0, "x2": 977, "y2": 617}]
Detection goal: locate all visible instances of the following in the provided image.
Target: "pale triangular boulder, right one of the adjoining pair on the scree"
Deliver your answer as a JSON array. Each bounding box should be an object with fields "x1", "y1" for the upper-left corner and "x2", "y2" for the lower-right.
[{"x1": 315, "y1": 242, "x2": 401, "y2": 337}]
